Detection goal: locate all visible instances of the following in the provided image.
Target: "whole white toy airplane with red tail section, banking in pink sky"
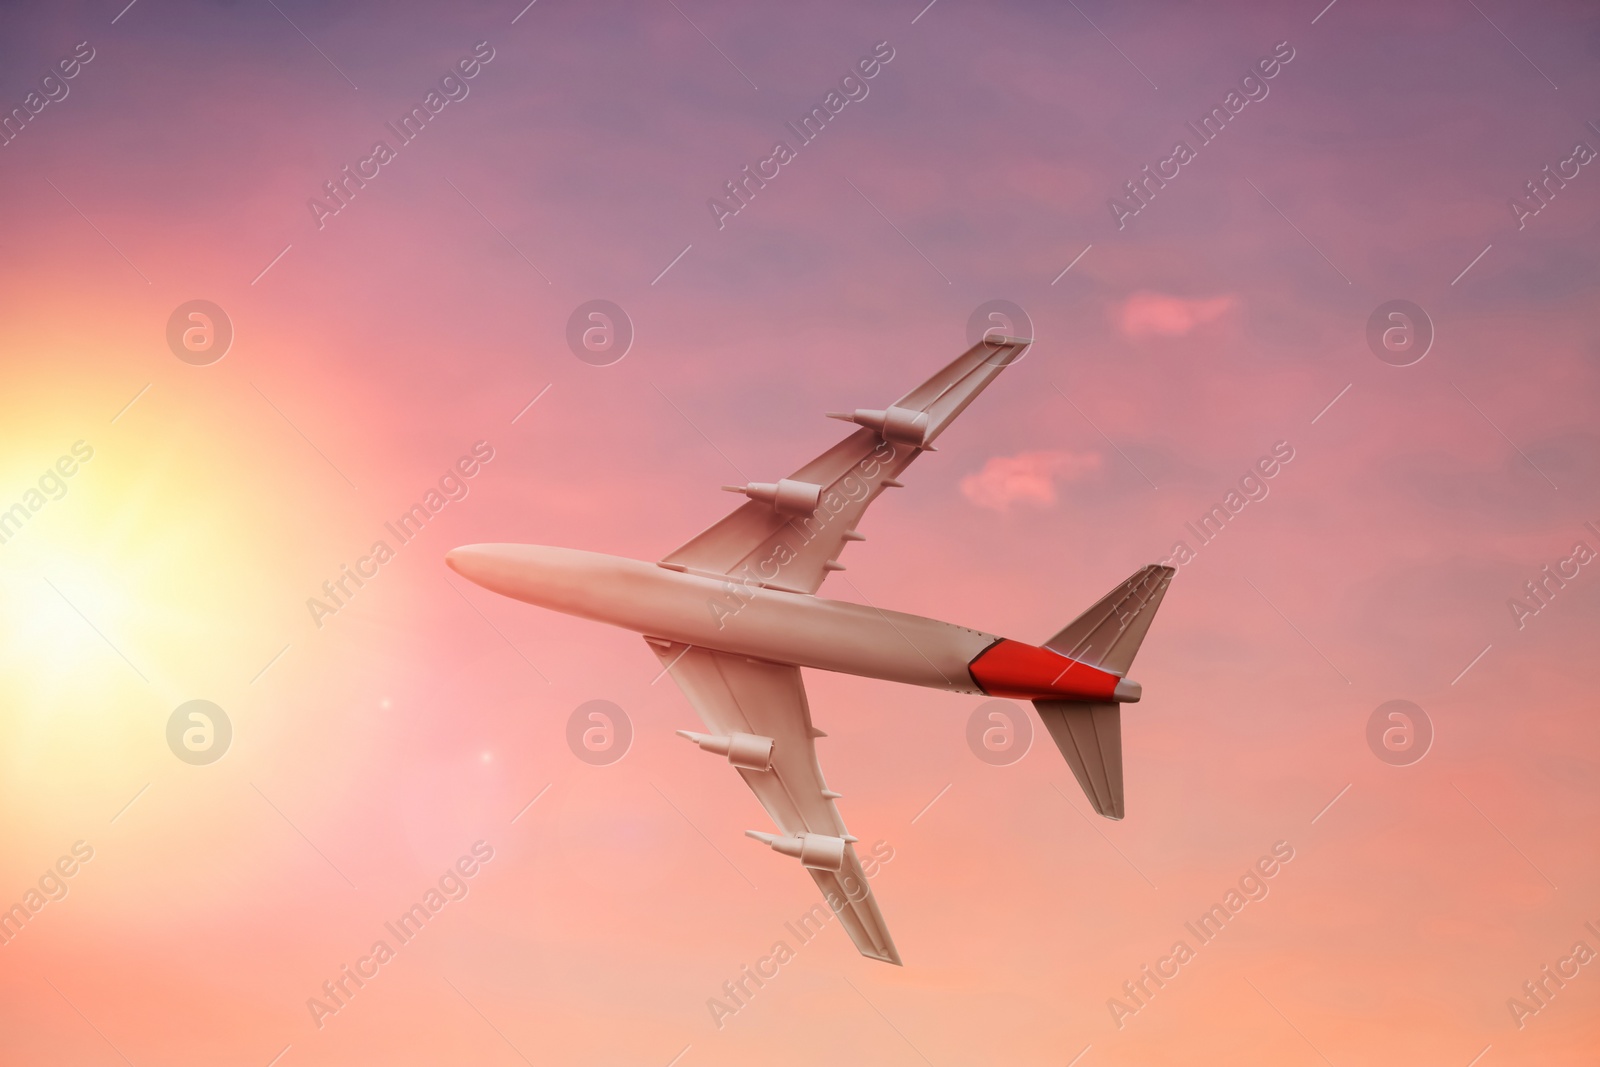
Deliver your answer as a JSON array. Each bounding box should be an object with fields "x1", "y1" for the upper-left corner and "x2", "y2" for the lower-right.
[{"x1": 445, "y1": 334, "x2": 1174, "y2": 965}]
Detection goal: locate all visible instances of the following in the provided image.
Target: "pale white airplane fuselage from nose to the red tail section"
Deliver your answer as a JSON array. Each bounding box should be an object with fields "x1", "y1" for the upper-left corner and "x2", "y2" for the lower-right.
[{"x1": 446, "y1": 544, "x2": 1000, "y2": 693}]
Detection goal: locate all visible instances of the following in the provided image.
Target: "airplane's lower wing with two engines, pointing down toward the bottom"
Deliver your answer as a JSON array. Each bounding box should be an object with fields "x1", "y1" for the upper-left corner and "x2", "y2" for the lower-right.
[{"x1": 645, "y1": 638, "x2": 901, "y2": 965}]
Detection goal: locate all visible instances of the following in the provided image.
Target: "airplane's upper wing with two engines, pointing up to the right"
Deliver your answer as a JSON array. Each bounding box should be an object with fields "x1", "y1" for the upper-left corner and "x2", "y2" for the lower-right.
[{"x1": 661, "y1": 336, "x2": 1030, "y2": 593}]
